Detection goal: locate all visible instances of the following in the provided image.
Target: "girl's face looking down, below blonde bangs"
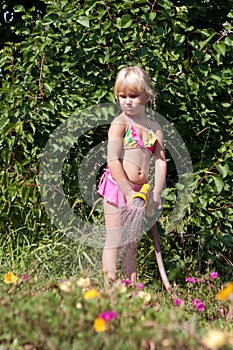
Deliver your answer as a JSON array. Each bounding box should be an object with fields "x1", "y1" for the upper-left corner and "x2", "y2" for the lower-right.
[{"x1": 118, "y1": 91, "x2": 148, "y2": 117}]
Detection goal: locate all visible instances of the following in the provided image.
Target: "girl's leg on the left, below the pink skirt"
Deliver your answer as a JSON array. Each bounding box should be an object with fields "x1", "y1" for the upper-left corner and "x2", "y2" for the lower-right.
[{"x1": 102, "y1": 202, "x2": 121, "y2": 285}]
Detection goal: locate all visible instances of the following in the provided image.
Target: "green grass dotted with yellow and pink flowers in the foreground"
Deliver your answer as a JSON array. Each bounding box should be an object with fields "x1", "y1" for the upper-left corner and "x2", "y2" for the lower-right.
[{"x1": 0, "y1": 240, "x2": 233, "y2": 350}]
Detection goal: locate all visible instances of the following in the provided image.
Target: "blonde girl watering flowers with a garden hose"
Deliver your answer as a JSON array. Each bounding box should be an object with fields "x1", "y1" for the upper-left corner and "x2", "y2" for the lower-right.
[{"x1": 98, "y1": 66, "x2": 166, "y2": 285}]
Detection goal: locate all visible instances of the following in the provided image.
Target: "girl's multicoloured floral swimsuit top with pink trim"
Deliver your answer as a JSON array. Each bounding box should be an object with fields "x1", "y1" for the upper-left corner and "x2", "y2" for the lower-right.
[{"x1": 123, "y1": 117, "x2": 157, "y2": 154}]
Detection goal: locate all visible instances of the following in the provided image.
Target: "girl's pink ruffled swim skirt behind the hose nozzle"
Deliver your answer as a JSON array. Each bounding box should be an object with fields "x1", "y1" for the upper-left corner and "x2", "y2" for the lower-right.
[{"x1": 97, "y1": 168, "x2": 141, "y2": 207}]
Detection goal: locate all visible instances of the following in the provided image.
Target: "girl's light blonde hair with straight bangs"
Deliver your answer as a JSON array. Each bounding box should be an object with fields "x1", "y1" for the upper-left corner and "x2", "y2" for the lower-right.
[{"x1": 114, "y1": 66, "x2": 155, "y2": 107}]
